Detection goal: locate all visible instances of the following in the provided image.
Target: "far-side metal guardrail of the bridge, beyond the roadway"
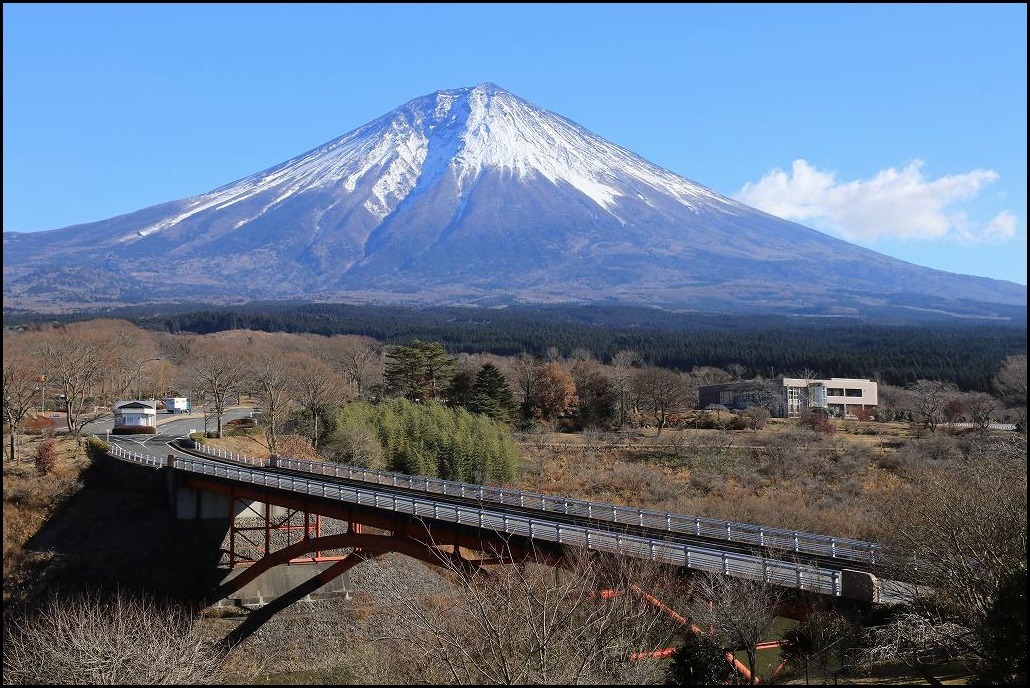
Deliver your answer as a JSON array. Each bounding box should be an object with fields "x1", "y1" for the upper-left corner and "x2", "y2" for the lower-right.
[{"x1": 185, "y1": 443, "x2": 881, "y2": 564}]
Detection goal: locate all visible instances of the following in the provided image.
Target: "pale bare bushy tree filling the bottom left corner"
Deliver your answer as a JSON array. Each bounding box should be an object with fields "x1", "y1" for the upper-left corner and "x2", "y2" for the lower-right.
[{"x1": 3, "y1": 593, "x2": 221, "y2": 686}]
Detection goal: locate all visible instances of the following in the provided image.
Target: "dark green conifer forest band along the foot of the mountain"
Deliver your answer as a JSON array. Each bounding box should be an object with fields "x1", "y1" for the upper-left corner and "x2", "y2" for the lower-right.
[{"x1": 5, "y1": 303, "x2": 1027, "y2": 391}]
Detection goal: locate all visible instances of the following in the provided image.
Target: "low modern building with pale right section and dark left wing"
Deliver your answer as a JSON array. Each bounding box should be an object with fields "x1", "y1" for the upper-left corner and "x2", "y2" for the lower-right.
[{"x1": 697, "y1": 377, "x2": 879, "y2": 418}]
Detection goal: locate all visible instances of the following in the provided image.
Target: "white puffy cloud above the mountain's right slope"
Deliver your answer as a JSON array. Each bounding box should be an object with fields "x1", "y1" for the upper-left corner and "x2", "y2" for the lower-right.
[{"x1": 733, "y1": 160, "x2": 1018, "y2": 244}]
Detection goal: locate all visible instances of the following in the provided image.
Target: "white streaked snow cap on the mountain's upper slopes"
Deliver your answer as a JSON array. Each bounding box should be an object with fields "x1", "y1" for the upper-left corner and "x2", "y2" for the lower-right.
[{"x1": 122, "y1": 84, "x2": 735, "y2": 241}]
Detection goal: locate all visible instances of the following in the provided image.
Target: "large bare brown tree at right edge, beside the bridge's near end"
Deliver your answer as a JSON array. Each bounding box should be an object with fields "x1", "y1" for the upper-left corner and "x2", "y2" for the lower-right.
[{"x1": 870, "y1": 436, "x2": 1027, "y2": 679}]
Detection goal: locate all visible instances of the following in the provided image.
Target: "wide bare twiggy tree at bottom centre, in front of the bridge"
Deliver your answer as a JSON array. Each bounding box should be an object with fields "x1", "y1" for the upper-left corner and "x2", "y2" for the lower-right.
[{"x1": 365, "y1": 543, "x2": 676, "y2": 685}]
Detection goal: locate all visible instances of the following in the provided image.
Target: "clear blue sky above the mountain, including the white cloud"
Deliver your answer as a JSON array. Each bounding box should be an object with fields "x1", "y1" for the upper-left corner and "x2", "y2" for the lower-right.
[{"x1": 3, "y1": 3, "x2": 1027, "y2": 284}]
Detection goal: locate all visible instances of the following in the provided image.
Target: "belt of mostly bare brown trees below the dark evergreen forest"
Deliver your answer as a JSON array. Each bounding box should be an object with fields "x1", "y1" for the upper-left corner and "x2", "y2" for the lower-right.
[{"x1": 3, "y1": 319, "x2": 1026, "y2": 467}]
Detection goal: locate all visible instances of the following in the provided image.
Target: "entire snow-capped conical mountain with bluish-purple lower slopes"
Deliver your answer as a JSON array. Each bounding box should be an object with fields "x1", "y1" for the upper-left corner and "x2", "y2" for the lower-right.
[{"x1": 3, "y1": 83, "x2": 1027, "y2": 319}]
